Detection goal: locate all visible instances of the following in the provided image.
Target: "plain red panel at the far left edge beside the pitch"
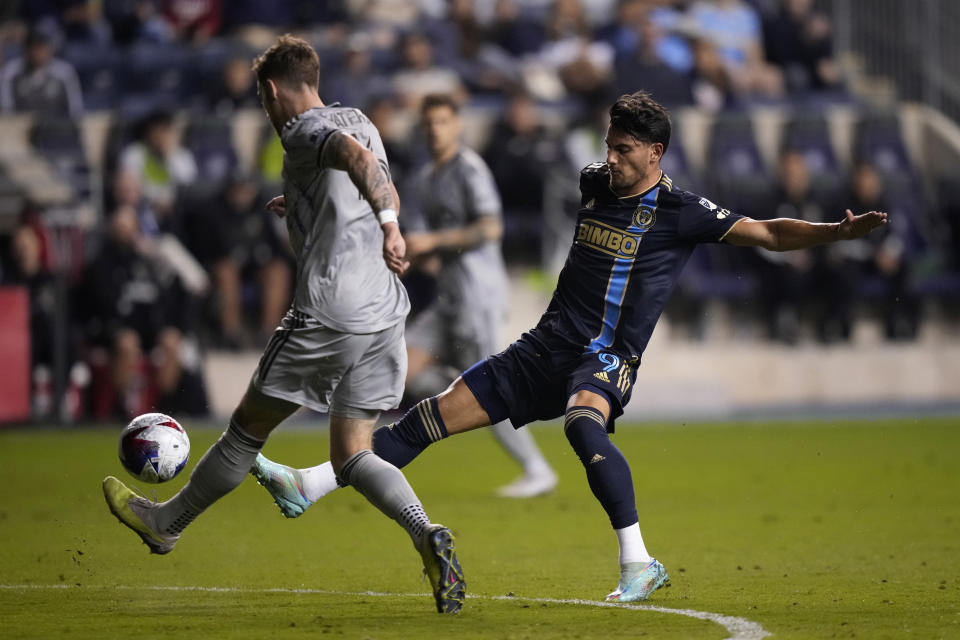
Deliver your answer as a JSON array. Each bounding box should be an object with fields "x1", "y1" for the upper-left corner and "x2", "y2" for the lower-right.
[{"x1": 0, "y1": 287, "x2": 30, "y2": 422}]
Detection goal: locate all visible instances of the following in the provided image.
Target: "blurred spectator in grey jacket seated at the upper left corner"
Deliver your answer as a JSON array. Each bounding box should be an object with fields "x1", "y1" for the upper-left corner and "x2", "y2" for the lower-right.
[{"x1": 0, "y1": 23, "x2": 83, "y2": 118}]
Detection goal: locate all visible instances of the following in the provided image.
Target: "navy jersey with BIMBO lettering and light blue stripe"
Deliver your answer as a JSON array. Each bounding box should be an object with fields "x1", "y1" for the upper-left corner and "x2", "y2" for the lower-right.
[{"x1": 537, "y1": 163, "x2": 743, "y2": 362}]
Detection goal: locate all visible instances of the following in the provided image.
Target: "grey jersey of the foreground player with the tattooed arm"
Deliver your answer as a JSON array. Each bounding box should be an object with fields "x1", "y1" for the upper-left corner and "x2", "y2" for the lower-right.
[{"x1": 280, "y1": 106, "x2": 410, "y2": 333}]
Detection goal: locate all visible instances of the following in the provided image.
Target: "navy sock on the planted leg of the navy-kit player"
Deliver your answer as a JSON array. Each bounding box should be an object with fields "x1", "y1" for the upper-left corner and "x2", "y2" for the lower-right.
[{"x1": 563, "y1": 407, "x2": 638, "y2": 529}]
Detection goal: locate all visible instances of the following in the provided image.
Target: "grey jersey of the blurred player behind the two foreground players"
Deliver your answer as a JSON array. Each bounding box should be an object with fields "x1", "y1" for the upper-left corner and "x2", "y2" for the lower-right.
[{"x1": 415, "y1": 147, "x2": 507, "y2": 313}]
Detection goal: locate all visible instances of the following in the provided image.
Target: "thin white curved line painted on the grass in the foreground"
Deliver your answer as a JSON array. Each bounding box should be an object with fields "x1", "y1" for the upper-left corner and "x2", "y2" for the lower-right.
[{"x1": 0, "y1": 584, "x2": 771, "y2": 640}]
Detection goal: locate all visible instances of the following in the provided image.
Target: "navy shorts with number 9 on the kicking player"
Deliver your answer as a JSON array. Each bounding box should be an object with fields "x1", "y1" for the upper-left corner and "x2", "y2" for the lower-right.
[{"x1": 463, "y1": 329, "x2": 637, "y2": 432}]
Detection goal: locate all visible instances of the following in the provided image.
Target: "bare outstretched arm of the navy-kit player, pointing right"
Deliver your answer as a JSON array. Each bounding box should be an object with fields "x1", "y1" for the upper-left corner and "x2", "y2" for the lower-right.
[{"x1": 723, "y1": 209, "x2": 887, "y2": 251}]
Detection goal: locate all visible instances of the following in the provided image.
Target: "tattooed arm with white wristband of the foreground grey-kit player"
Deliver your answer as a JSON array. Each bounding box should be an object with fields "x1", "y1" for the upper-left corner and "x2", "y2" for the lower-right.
[{"x1": 323, "y1": 132, "x2": 410, "y2": 274}]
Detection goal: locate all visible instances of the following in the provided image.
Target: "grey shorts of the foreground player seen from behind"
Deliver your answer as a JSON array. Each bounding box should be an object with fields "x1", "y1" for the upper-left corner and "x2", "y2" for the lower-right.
[{"x1": 251, "y1": 310, "x2": 407, "y2": 418}]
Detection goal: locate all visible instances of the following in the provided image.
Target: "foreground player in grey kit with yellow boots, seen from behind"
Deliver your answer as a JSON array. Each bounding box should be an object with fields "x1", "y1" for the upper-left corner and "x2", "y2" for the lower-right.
[{"x1": 103, "y1": 35, "x2": 465, "y2": 613}]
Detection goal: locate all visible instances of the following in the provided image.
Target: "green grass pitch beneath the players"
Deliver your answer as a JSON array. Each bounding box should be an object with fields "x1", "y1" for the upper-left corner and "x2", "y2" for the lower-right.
[{"x1": 0, "y1": 419, "x2": 960, "y2": 640}]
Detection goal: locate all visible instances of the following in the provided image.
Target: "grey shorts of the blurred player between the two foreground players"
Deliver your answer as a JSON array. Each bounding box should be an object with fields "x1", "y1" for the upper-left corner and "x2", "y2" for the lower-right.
[{"x1": 407, "y1": 303, "x2": 504, "y2": 371}]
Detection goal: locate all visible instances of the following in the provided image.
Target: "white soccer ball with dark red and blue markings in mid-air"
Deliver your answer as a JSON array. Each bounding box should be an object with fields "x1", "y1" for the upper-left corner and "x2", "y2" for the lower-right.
[{"x1": 120, "y1": 413, "x2": 190, "y2": 483}]
